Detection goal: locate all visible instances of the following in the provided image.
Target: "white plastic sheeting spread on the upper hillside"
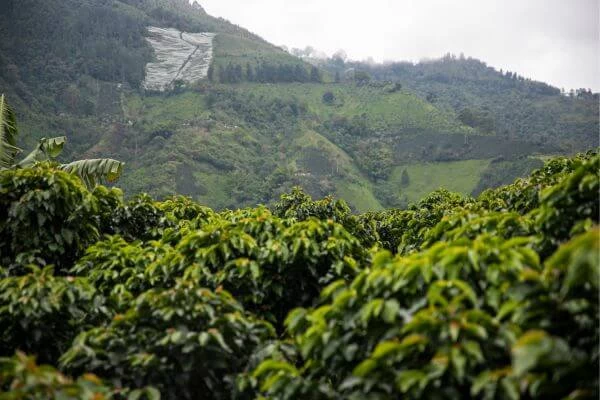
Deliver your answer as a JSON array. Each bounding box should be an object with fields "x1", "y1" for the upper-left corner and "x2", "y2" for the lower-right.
[{"x1": 144, "y1": 26, "x2": 215, "y2": 91}]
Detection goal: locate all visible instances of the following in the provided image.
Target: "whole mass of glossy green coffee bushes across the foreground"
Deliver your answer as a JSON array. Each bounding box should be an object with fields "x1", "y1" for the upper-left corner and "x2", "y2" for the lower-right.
[{"x1": 0, "y1": 152, "x2": 600, "y2": 400}]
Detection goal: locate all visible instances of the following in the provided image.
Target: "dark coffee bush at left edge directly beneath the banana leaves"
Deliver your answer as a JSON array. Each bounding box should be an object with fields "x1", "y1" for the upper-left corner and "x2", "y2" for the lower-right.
[{"x1": 0, "y1": 165, "x2": 98, "y2": 273}]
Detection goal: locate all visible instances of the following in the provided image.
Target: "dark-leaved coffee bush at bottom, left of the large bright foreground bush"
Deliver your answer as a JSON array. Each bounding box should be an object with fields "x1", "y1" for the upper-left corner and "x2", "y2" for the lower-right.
[{"x1": 61, "y1": 282, "x2": 274, "y2": 399}]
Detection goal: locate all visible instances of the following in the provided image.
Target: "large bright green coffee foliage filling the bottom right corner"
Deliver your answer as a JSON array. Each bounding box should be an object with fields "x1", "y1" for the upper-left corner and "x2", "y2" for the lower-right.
[{"x1": 254, "y1": 231, "x2": 599, "y2": 399}]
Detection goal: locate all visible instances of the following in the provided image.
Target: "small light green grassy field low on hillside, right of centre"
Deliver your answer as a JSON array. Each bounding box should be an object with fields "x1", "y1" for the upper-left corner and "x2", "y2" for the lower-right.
[{"x1": 388, "y1": 160, "x2": 490, "y2": 202}]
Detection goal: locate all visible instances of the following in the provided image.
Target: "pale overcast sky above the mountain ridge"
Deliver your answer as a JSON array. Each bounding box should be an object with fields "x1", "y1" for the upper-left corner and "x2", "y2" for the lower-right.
[{"x1": 199, "y1": 0, "x2": 600, "y2": 91}]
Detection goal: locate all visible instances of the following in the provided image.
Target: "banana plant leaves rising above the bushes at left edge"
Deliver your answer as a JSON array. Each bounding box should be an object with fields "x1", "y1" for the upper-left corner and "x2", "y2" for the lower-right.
[{"x1": 0, "y1": 95, "x2": 124, "y2": 188}]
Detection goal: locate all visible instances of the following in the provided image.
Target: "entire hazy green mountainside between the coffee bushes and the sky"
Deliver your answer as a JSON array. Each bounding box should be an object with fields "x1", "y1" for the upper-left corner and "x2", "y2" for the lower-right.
[{"x1": 0, "y1": 0, "x2": 598, "y2": 211}]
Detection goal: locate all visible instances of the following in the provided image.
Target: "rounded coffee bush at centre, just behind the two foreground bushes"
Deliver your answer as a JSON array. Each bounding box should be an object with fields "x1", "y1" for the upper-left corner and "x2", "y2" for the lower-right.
[{"x1": 166, "y1": 209, "x2": 367, "y2": 323}]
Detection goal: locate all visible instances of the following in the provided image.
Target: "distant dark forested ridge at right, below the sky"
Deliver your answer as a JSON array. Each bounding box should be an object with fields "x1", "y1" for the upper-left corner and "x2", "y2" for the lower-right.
[{"x1": 318, "y1": 54, "x2": 599, "y2": 150}]
